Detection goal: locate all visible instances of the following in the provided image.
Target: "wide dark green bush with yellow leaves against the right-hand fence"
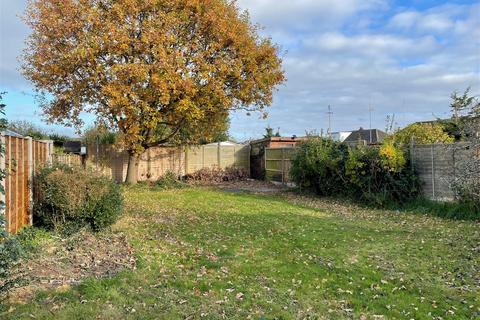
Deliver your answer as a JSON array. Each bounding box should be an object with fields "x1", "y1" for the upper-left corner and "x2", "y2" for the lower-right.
[{"x1": 291, "y1": 138, "x2": 420, "y2": 206}]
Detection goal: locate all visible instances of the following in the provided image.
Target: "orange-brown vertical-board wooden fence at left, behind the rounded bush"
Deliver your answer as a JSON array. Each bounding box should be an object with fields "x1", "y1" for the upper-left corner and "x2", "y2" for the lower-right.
[{"x1": 0, "y1": 135, "x2": 53, "y2": 233}]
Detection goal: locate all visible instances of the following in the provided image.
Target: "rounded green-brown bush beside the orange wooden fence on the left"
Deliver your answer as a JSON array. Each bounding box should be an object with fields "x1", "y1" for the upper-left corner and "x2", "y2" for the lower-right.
[{"x1": 34, "y1": 165, "x2": 123, "y2": 233}]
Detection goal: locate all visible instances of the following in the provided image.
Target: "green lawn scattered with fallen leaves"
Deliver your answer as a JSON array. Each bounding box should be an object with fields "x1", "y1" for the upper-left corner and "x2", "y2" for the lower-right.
[{"x1": 1, "y1": 187, "x2": 480, "y2": 319}]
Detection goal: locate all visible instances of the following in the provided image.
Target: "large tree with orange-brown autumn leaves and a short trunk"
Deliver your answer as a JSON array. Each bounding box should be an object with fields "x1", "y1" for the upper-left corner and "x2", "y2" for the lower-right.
[{"x1": 23, "y1": 0, "x2": 285, "y2": 182}]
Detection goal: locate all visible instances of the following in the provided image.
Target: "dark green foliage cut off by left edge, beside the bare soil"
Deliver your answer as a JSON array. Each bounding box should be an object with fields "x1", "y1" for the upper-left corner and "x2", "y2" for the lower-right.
[{"x1": 0, "y1": 215, "x2": 23, "y2": 302}]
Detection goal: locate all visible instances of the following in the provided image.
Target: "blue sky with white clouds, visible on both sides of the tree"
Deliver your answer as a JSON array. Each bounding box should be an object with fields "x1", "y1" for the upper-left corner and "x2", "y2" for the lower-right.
[{"x1": 0, "y1": 0, "x2": 480, "y2": 140}]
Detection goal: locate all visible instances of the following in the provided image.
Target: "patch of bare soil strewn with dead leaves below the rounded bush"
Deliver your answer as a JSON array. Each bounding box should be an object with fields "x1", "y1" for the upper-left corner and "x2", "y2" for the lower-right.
[{"x1": 10, "y1": 231, "x2": 136, "y2": 303}]
